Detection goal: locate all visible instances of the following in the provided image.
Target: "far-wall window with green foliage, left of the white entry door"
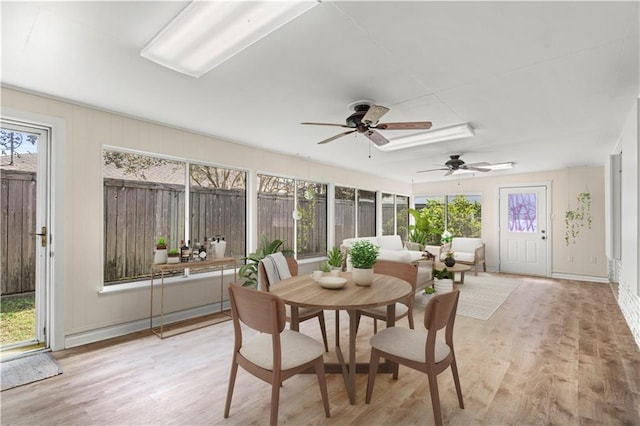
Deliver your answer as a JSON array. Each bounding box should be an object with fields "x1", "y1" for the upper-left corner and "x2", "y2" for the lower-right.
[{"x1": 415, "y1": 194, "x2": 482, "y2": 245}]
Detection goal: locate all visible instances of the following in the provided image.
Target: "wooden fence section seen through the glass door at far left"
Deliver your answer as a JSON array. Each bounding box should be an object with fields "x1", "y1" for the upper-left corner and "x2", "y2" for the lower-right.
[{"x1": 0, "y1": 169, "x2": 40, "y2": 295}]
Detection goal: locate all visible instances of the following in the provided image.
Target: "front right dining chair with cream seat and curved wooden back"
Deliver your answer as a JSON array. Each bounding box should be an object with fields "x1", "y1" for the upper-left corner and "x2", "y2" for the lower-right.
[{"x1": 365, "y1": 289, "x2": 464, "y2": 425}]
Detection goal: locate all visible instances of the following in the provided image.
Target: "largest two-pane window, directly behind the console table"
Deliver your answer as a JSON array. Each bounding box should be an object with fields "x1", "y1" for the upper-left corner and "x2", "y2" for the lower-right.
[{"x1": 103, "y1": 150, "x2": 246, "y2": 285}]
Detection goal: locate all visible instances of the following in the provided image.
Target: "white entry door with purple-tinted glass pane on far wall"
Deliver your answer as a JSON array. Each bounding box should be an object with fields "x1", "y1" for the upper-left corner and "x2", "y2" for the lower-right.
[{"x1": 500, "y1": 185, "x2": 549, "y2": 276}]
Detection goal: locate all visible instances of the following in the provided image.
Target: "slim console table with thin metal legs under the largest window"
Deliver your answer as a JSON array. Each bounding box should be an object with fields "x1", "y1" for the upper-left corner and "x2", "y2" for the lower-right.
[{"x1": 149, "y1": 257, "x2": 236, "y2": 339}]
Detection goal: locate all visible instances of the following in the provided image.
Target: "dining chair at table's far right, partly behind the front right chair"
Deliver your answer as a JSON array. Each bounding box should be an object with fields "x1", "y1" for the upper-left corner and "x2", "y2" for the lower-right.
[{"x1": 356, "y1": 260, "x2": 418, "y2": 333}]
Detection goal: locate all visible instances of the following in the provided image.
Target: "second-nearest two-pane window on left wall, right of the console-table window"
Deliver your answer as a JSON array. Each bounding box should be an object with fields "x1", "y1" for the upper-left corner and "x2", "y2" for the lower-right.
[{"x1": 258, "y1": 174, "x2": 327, "y2": 259}]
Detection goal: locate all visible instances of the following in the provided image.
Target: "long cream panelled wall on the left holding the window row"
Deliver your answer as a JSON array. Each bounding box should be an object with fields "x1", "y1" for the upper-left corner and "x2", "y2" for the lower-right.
[{"x1": 0, "y1": 88, "x2": 411, "y2": 349}]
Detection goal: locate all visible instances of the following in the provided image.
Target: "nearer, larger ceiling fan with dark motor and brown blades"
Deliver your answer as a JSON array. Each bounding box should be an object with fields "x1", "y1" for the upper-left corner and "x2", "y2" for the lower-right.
[{"x1": 300, "y1": 101, "x2": 431, "y2": 146}]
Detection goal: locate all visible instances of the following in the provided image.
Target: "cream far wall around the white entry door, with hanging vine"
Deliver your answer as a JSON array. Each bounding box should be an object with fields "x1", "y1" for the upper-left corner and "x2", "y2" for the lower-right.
[{"x1": 413, "y1": 165, "x2": 608, "y2": 281}]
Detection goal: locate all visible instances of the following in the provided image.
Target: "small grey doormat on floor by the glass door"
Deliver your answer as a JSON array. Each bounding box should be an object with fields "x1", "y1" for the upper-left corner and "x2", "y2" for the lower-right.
[{"x1": 0, "y1": 352, "x2": 62, "y2": 391}]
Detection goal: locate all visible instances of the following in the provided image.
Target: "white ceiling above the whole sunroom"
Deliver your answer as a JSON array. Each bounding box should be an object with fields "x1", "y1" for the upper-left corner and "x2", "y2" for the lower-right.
[{"x1": 1, "y1": 0, "x2": 640, "y2": 182}]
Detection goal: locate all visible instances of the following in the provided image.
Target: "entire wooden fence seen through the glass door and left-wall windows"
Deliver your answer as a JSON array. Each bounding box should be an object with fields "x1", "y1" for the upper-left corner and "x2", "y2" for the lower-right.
[{"x1": 0, "y1": 170, "x2": 375, "y2": 294}]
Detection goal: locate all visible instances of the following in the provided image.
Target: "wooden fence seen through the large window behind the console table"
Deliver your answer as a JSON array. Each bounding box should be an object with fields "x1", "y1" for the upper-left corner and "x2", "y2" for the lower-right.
[{"x1": 104, "y1": 179, "x2": 246, "y2": 284}]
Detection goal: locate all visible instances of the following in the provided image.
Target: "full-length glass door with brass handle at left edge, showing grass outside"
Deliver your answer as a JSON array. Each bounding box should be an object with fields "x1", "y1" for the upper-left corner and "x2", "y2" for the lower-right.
[{"x1": 0, "y1": 118, "x2": 51, "y2": 356}]
